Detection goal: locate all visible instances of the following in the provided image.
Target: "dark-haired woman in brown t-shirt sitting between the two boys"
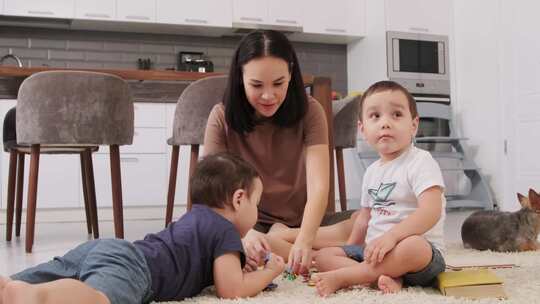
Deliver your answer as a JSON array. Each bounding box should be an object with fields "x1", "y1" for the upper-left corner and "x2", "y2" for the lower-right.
[{"x1": 204, "y1": 31, "x2": 351, "y2": 273}]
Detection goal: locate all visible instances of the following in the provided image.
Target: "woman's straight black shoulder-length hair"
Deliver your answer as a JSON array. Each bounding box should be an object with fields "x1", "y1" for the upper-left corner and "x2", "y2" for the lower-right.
[{"x1": 223, "y1": 30, "x2": 308, "y2": 134}]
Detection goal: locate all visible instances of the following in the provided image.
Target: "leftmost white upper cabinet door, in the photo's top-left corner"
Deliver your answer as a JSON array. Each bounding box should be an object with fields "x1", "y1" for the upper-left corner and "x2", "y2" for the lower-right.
[{"x1": 4, "y1": 0, "x2": 75, "y2": 18}]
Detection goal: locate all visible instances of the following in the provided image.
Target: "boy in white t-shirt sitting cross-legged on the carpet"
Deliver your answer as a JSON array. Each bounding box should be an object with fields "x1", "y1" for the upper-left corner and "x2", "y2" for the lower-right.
[{"x1": 313, "y1": 81, "x2": 446, "y2": 296}]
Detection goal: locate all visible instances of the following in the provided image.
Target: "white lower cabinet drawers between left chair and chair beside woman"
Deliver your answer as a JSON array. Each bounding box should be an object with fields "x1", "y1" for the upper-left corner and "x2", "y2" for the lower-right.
[{"x1": 94, "y1": 102, "x2": 168, "y2": 206}]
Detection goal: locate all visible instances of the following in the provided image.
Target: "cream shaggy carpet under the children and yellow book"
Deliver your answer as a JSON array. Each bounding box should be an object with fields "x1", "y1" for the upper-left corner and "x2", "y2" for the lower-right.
[{"x1": 160, "y1": 244, "x2": 540, "y2": 304}]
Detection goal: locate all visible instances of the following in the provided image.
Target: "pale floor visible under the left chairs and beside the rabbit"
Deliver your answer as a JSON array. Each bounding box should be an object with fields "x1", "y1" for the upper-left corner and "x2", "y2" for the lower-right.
[{"x1": 0, "y1": 211, "x2": 471, "y2": 276}]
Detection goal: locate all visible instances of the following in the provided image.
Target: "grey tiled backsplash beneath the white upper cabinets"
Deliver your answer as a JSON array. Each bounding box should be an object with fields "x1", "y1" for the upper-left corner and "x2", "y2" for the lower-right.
[{"x1": 0, "y1": 26, "x2": 347, "y2": 94}]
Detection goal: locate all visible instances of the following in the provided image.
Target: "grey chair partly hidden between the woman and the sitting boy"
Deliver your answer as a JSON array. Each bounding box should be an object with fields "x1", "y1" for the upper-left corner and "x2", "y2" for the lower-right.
[{"x1": 332, "y1": 95, "x2": 361, "y2": 211}]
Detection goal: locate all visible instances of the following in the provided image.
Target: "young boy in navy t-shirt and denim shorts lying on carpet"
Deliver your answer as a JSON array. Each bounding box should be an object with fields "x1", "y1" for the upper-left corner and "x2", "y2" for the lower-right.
[{"x1": 0, "y1": 153, "x2": 285, "y2": 304}]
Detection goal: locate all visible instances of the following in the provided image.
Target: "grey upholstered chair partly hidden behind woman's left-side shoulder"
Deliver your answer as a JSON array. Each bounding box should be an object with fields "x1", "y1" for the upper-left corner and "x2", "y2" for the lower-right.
[{"x1": 165, "y1": 76, "x2": 227, "y2": 226}]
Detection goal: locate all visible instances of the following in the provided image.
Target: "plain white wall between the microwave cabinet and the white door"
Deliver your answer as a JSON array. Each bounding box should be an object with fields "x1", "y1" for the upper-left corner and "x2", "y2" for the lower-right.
[{"x1": 450, "y1": 0, "x2": 504, "y2": 208}]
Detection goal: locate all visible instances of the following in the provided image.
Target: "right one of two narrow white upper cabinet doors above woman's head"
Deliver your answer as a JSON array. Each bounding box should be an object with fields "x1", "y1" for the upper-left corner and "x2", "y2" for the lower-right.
[{"x1": 267, "y1": 0, "x2": 303, "y2": 26}]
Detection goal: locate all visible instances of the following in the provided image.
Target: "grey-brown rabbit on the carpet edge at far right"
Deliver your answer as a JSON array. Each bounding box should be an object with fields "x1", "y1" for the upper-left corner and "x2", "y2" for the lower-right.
[{"x1": 461, "y1": 189, "x2": 540, "y2": 252}]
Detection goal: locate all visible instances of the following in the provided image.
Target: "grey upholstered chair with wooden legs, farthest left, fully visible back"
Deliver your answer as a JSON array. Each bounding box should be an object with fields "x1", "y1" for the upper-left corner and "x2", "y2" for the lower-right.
[{"x1": 8, "y1": 71, "x2": 133, "y2": 252}]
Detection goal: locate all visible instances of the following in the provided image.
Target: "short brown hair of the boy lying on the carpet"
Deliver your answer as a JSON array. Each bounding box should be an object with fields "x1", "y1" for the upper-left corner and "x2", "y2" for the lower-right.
[{"x1": 189, "y1": 152, "x2": 260, "y2": 208}]
